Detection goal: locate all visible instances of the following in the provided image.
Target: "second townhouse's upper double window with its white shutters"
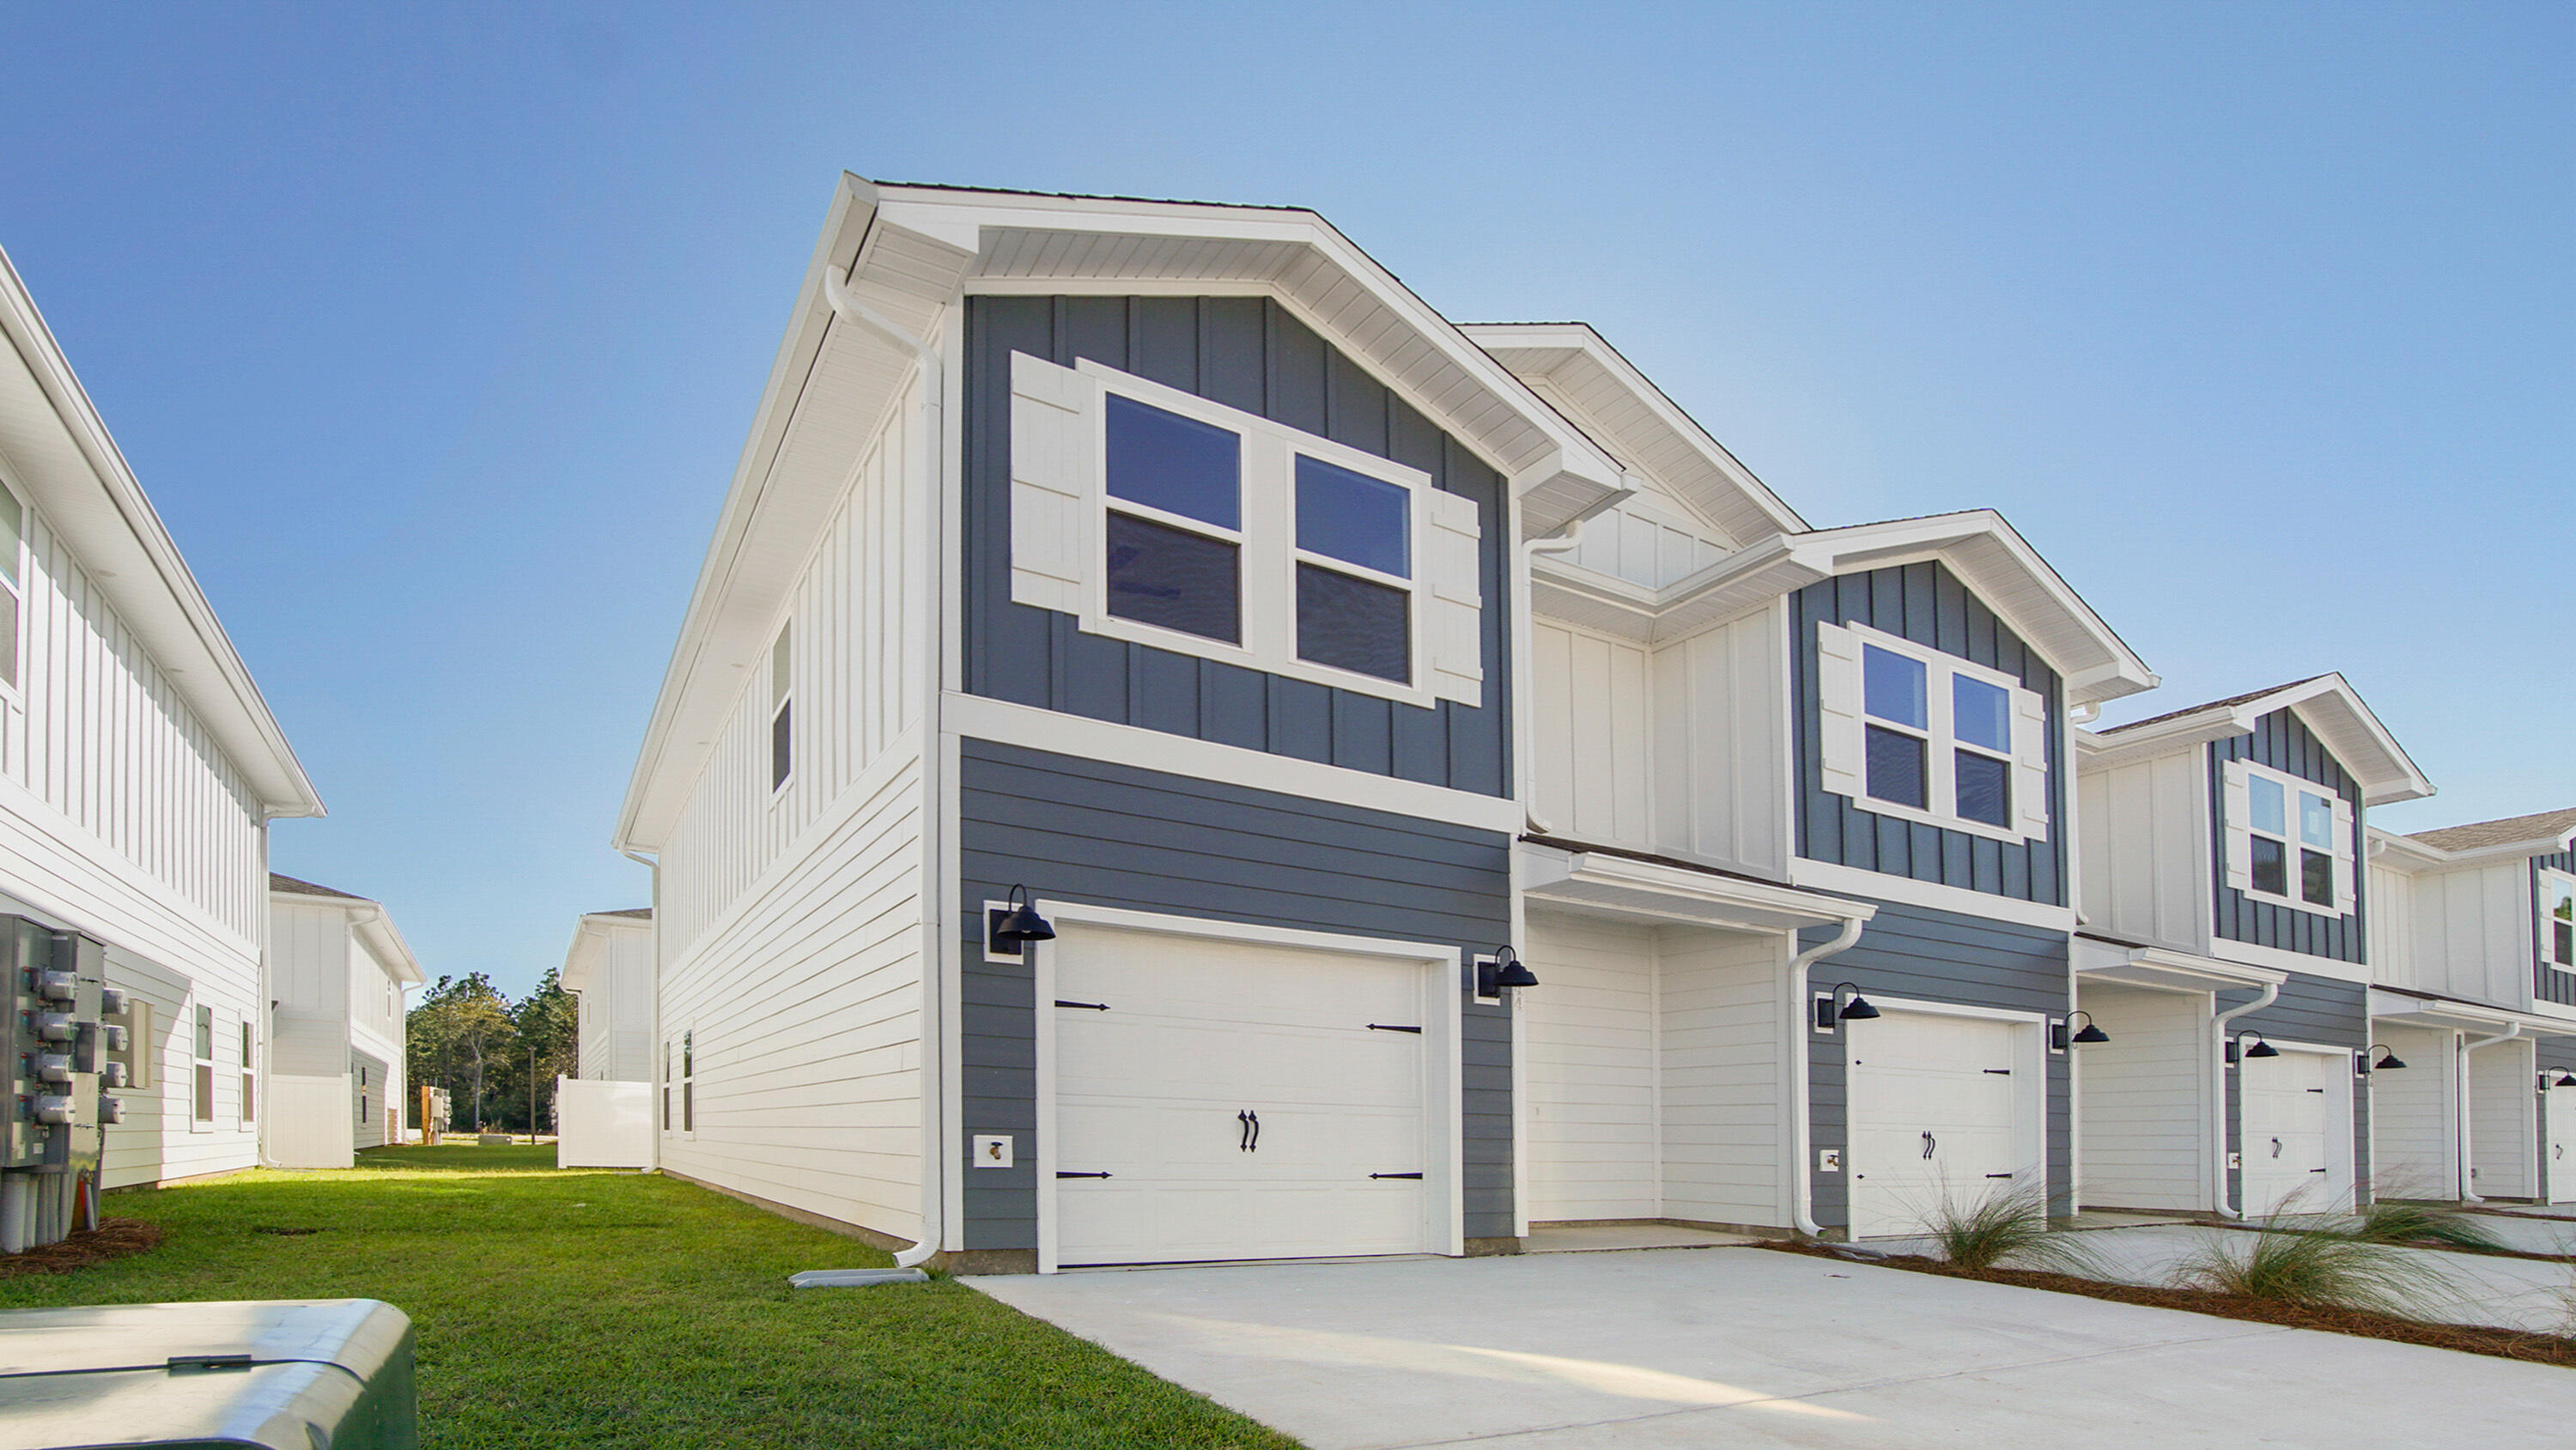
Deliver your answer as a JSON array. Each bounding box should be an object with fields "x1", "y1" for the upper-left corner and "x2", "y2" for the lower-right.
[{"x1": 1816, "y1": 623, "x2": 2048, "y2": 842}]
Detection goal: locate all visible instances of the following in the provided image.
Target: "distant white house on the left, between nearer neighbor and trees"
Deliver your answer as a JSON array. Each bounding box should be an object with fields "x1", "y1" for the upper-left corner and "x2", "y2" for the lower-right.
[{"x1": 260, "y1": 873, "x2": 422, "y2": 1167}]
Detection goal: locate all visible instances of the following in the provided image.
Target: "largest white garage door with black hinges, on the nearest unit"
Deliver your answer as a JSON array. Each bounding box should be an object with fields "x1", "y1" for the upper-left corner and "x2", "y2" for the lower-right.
[{"x1": 1054, "y1": 925, "x2": 1435, "y2": 1265}]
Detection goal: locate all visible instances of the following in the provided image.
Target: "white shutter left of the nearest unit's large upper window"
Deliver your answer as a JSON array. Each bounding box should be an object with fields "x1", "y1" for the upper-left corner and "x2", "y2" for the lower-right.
[{"x1": 1010, "y1": 353, "x2": 1100, "y2": 616}]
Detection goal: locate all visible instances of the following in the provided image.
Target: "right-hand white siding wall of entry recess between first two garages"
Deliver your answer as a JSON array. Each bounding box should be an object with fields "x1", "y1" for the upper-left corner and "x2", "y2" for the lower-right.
[{"x1": 1659, "y1": 927, "x2": 1790, "y2": 1229}]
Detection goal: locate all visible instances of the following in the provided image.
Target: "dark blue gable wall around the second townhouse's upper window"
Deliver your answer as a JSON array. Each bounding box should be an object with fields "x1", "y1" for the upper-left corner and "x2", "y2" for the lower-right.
[{"x1": 1790, "y1": 564, "x2": 2066, "y2": 907}]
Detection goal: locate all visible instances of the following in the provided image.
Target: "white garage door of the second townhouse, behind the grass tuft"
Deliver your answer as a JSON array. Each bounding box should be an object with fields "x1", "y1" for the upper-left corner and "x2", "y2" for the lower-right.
[{"x1": 1842, "y1": 1007, "x2": 2040, "y2": 1239}]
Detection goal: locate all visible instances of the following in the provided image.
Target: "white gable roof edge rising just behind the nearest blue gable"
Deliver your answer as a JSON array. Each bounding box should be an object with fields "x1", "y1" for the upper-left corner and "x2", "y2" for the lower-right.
[{"x1": 1461, "y1": 322, "x2": 1808, "y2": 549}]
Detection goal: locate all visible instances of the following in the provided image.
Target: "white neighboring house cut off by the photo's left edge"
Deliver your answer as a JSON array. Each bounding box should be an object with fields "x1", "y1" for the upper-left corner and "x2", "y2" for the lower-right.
[{"x1": 0, "y1": 240, "x2": 322, "y2": 1205}]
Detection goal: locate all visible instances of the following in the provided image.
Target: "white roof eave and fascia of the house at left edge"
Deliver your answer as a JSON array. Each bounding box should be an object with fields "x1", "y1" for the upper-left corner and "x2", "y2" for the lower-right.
[{"x1": 0, "y1": 252, "x2": 325, "y2": 819}]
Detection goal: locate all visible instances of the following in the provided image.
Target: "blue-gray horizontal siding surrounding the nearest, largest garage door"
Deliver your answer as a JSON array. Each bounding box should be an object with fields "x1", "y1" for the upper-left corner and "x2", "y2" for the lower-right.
[{"x1": 956, "y1": 739, "x2": 1512, "y2": 1252}]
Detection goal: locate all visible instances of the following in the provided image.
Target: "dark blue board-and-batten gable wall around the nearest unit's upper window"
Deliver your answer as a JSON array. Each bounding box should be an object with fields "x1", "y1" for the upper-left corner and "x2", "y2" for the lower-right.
[{"x1": 963, "y1": 296, "x2": 1510, "y2": 796}]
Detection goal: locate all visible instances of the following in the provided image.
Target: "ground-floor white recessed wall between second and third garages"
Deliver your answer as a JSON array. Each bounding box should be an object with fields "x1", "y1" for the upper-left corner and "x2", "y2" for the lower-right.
[{"x1": 2076, "y1": 986, "x2": 2213, "y2": 1210}]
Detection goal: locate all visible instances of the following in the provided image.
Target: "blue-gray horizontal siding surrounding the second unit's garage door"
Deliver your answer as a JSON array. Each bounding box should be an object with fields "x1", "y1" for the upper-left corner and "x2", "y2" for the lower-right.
[{"x1": 1798, "y1": 901, "x2": 2074, "y2": 1229}]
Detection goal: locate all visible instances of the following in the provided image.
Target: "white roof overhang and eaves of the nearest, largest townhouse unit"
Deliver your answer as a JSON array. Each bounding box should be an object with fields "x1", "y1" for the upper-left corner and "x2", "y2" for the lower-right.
[{"x1": 613, "y1": 175, "x2": 1620, "y2": 850}]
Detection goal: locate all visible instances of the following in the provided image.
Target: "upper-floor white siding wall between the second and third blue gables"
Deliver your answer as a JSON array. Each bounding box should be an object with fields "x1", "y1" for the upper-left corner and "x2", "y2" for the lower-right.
[{"x1": 2076, "y1": 752, "x2": 2210, "y2": 950}]
